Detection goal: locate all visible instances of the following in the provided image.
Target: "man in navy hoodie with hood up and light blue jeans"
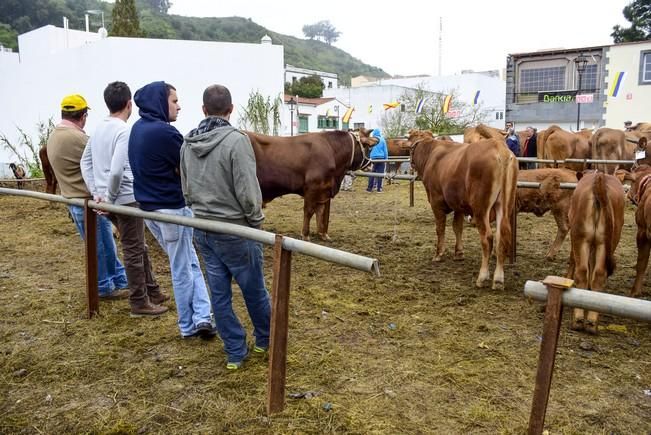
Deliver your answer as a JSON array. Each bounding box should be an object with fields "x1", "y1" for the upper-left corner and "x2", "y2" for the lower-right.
[{"x1": 129, "y1": 82, "x2": 216, "y2": 339}]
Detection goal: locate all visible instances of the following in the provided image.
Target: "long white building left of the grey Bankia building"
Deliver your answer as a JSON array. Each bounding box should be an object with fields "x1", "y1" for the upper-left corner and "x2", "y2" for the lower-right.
[{"x1": 324, "y1": 72, "x2": 506, "y2": 128}]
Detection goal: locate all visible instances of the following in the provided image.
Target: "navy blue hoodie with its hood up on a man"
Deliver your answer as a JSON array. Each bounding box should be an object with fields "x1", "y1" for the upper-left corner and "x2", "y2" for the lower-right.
[{"x1": 129, "y1": 82, "x2": 185, "y2": 211}]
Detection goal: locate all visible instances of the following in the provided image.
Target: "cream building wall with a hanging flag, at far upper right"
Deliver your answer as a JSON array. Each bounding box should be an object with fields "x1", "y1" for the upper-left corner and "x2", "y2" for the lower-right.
[{"x1": 604, "y1": 41, "x2": 651, "y2": 129}]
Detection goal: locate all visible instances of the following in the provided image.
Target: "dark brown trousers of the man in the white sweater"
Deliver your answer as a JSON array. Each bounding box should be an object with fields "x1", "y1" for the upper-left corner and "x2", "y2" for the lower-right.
[{"x1": 111, "y1": 203, "x2": 160, "y2": 306}]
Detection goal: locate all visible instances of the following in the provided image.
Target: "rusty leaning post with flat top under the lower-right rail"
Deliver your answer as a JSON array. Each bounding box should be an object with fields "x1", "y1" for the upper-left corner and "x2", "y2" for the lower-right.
[{"x1": 528, "y1": 276, "x2": 574, "y2": 435}]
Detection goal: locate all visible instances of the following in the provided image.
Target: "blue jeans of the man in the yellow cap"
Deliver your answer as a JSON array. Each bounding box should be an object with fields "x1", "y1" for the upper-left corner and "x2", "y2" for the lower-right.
[{"x1": 68, "y1": 205, "x2": 128, "y2": 296}]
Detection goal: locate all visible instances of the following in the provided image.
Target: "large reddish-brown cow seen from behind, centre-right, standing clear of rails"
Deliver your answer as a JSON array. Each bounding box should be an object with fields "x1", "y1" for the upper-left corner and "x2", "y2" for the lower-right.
[{"x1": 409, "y1": 133, "x2": 518, "y2": 288}]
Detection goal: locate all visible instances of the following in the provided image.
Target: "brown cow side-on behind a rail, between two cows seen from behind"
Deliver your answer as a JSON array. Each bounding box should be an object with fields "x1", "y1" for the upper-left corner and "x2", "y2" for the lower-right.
[{"x1": 516, "y1": 168, "x2": 576, "y2": 260}]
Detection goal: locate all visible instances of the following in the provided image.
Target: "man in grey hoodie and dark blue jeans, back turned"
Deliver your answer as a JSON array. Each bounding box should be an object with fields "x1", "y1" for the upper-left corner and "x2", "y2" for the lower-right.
[{"x1": 181, "y1": 85, "x2": 271, "y2": 370}]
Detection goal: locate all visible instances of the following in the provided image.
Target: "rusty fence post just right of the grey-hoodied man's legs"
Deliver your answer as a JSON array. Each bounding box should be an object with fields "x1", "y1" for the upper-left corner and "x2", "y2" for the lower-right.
[{"x1": 267, "y1": 235, "x2": 292, "y2": 414}]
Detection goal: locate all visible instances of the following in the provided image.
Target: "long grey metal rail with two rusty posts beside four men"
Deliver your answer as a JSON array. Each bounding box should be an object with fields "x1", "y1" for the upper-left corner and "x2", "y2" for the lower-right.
[{"x1": 0, "y1": 188, "x2": 380, "y2": 414}]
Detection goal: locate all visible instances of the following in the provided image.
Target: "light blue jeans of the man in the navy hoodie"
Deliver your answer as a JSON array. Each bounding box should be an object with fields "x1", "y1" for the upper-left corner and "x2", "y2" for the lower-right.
[{"x1": 145, "y1": 207, "x2": 212, "y2": 337}]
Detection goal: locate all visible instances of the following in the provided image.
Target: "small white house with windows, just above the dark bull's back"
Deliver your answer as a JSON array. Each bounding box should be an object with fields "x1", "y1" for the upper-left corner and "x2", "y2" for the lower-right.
[{"x1": 281, "y1": 95, "x2": 348, "y2": 136}]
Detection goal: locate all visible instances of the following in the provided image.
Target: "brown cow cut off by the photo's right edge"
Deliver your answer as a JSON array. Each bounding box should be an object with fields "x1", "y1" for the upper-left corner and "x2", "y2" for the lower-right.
[{"x1": 627, "y1": 165, "x2": 651, "y2": 297}]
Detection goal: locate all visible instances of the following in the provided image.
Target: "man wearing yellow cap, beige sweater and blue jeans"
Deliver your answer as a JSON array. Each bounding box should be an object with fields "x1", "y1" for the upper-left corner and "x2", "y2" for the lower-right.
[{"x1": 46, "y1": 94, "x2": 129, "y2": 299}]
